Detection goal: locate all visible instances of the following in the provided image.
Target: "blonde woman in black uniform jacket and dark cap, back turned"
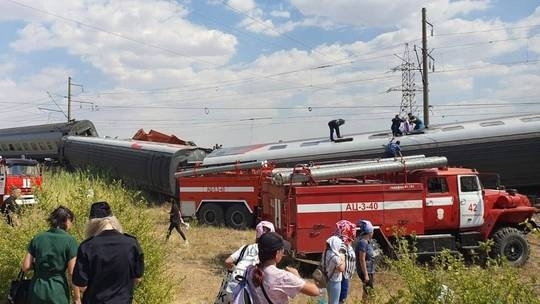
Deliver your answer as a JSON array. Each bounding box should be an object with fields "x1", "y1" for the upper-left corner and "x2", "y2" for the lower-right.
[{"x1": 73, "y1": 202, "x2": 144, "y2": 304}]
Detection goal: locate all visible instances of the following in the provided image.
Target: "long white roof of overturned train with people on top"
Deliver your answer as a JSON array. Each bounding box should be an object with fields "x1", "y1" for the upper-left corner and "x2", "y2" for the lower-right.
[{"x1": 203, "y1": 113, "x2": 540, "y2": 165}]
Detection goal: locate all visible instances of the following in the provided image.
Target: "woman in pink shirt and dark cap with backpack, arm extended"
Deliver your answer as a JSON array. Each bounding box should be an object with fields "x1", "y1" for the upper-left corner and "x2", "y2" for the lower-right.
[{"x1": 237, "y1": 232, "x2": 321, "y2": 304}]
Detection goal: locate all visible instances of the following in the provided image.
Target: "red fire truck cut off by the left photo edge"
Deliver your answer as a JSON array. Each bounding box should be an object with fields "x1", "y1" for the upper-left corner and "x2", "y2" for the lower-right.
[{"x1": 0, "y1": 158, "x2": 42, "y2": 205}]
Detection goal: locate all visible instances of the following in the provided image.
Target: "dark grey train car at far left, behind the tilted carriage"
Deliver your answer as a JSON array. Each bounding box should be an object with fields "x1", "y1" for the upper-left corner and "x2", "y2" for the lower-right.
[{"x1": 0, "y1": 120, "x2": 98, "y2": 160}]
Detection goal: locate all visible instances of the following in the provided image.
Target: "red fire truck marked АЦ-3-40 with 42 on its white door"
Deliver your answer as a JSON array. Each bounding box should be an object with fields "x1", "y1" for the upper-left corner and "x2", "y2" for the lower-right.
[{"x1": 261, "y1": 164, "x2": 535, "y2": 265}]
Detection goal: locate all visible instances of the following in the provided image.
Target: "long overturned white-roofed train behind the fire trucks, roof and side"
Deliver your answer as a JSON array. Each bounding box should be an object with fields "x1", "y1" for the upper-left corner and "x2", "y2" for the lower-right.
[{"x1": 203, "y1": 113, "x2": 540, "y2": 190}]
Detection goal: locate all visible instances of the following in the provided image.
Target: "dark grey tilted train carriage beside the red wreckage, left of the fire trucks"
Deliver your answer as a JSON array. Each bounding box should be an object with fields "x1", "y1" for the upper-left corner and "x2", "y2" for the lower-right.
[{"x1": 62, "y1": 136, "x2": 207, "y2": 197}]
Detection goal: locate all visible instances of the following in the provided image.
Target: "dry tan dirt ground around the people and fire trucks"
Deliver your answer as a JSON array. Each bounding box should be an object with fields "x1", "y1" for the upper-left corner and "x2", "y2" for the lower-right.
[{"x1": 155, "y1": 208, "x2": 540, "y2": 304}]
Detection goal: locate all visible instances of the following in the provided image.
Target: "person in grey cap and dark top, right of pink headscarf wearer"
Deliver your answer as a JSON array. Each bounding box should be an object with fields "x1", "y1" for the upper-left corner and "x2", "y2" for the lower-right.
[{"x1": 355, "y1": 220, "x2": 375, "y2": 299}]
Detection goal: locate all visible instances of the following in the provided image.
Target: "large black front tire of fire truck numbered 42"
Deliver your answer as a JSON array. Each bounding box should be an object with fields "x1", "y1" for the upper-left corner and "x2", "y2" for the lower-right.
[{"x1": 492, "y1": 227, "x2": 530, "y2": 266}]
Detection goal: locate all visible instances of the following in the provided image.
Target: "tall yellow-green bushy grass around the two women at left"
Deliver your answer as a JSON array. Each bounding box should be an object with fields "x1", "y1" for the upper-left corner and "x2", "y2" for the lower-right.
[{"x1": 0, "y1": 171, "x2": 174, "y2": 303}]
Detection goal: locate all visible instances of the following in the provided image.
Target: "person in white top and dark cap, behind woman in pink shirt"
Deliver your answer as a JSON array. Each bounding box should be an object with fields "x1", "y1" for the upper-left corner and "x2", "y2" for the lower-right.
[{"x1": 214, "y1": 221, "x2": 275, "y2": 304}]
